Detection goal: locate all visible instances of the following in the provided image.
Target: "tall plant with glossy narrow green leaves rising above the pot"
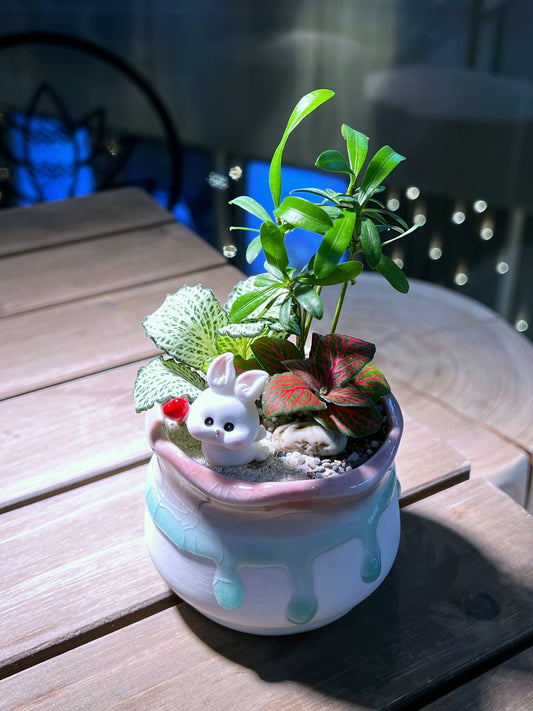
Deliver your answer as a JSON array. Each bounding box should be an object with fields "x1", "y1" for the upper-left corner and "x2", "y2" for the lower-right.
[{"x1": 229, "y1": 89, "x2": 415, "y2": 350}]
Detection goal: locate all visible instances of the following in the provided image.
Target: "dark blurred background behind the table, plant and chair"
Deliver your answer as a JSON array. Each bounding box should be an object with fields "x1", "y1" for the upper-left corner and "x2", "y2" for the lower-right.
[{"x1": 0, "y1": 0, "x2": 533, "y2": 335}]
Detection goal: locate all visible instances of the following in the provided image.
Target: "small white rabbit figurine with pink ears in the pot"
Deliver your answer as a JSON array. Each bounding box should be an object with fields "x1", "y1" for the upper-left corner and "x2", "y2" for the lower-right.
[{"x1": 186, "y1": 353, "x2": 269, "y2": 466}]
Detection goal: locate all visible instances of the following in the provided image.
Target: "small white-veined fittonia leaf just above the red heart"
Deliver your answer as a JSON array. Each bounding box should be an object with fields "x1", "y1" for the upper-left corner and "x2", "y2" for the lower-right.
[{"x1": 134, "y1": 356, "x2": 206, "y2": 412}]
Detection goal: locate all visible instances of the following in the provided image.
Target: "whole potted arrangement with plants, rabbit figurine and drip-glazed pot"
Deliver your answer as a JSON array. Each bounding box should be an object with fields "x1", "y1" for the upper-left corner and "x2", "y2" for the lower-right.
[{"x1": 135, "y1": 90, "x2": 413, "y2": 634}]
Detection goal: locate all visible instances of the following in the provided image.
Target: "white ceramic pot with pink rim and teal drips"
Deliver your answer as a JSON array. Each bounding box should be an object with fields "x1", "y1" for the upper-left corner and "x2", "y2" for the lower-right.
[{"x1": 145, "y1": 395, "x2": 403, "y2": 635}]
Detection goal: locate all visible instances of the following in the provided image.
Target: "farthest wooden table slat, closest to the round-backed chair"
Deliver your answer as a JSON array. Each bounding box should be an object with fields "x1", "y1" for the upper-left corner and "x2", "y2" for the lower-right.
[{"x1": 0, "y1": 188, "x2": 174, "y2": 256}]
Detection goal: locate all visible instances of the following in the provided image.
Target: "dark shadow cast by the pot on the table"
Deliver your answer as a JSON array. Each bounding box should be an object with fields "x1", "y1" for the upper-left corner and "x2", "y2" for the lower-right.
[{"x1": 177, "y1": 512, "x2": 533, "y2": 708}]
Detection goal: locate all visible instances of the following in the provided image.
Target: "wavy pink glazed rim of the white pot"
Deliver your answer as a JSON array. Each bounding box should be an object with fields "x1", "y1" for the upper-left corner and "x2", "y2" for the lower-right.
[{"x1": 146, "y1": 394, "x2": 403, "y2": 508}]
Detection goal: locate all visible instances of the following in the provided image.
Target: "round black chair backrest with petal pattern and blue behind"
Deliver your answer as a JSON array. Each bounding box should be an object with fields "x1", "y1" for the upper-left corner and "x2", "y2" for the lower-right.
[{"x1": 0, "y1": 32, "x2": 182, "y2": 209}]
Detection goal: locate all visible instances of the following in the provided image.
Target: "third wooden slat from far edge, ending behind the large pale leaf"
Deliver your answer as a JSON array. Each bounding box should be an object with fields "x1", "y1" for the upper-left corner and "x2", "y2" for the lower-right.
[{"x1": 0, "y1": 266, "x2": 240, "y2": 398}]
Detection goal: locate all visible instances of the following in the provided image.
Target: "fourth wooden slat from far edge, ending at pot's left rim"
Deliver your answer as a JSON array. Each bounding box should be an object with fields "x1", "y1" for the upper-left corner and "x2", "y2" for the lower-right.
[{"x1": 0, "y1": 361, "x2": 151, "y2": 511}]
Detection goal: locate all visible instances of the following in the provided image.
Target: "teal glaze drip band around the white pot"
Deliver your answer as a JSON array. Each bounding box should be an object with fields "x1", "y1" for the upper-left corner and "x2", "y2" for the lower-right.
[{"x1": 146, "y1": 465, "x2": 399, "y2": 625}]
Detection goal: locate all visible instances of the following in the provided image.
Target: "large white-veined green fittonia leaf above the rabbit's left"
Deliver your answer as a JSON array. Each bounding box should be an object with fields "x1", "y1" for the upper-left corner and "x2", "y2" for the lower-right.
[{"x1": 143, "y1": 284, "x2": 228, "y2": 371}]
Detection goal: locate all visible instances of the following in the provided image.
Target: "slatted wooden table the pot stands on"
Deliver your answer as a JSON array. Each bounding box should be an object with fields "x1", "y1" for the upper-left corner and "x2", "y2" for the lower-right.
[{"x1": 0, "y1": 189, "x2": 533, "y2": 711}]
